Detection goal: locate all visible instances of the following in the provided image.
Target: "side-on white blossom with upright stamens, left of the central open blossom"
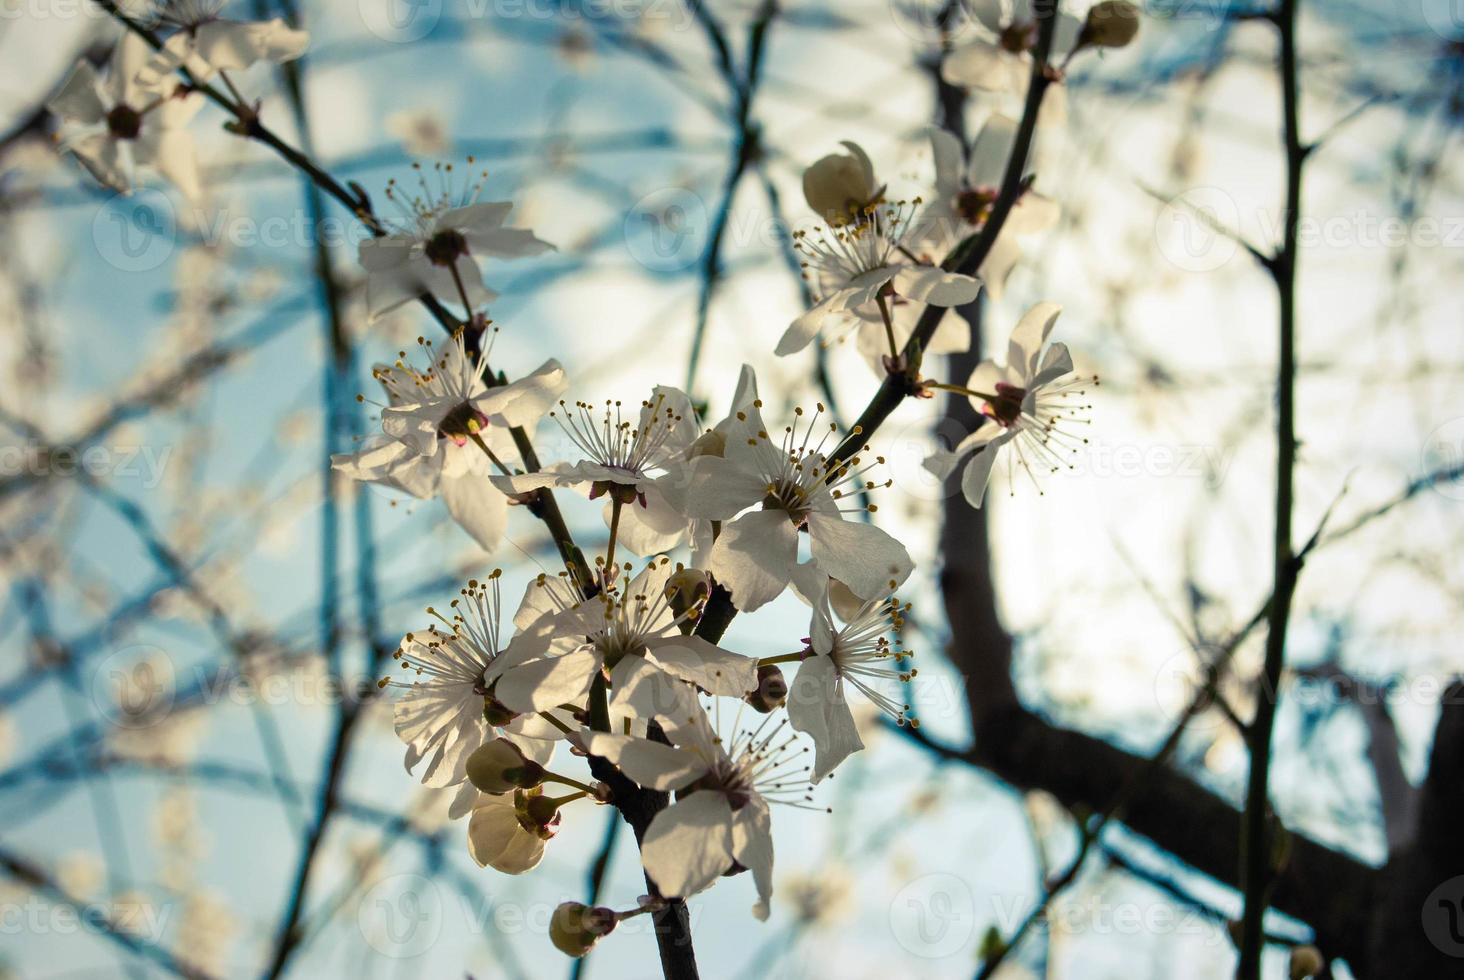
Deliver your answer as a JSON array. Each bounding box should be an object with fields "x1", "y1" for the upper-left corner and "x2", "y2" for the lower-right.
[{"x1": 493, "y1": 385, "x2": 701, "y2": 555}]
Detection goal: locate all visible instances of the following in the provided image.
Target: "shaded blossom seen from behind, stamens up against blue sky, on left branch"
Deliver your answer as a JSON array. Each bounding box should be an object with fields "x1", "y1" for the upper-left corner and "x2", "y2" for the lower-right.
[{"x1": 360, "y1": 157, "x2": 553, "y2": 321}]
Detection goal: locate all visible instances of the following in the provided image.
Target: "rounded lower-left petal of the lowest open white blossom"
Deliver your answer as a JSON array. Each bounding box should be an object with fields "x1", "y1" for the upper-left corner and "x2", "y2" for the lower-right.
[{"x1": 641, "y1": 790, "x2": 732, "y2": 898}]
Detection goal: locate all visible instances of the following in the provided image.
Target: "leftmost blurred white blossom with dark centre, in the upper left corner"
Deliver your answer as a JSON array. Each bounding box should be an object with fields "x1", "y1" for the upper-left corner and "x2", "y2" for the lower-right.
[{"x1": 47, "y1": 32, "x2": 203, "y2": 201}]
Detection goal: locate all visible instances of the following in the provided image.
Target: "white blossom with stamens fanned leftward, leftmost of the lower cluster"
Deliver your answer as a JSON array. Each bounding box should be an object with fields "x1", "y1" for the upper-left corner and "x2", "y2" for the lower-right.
[{"x1": 381, "y1": 570, "x2": 562, "y2": 819}]
